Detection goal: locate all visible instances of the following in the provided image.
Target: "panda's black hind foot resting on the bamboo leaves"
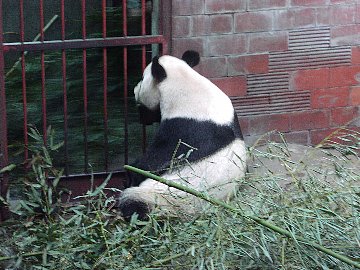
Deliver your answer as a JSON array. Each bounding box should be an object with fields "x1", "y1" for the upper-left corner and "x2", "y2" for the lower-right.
[{"x1": 119, "y1": 199, "x2": 151, "y2": 221}]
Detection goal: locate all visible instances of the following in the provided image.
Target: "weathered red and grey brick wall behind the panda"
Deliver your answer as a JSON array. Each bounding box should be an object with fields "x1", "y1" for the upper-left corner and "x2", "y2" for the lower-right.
[{"x1": 172, "y1": 0, "x2": 360, "y2": 144}]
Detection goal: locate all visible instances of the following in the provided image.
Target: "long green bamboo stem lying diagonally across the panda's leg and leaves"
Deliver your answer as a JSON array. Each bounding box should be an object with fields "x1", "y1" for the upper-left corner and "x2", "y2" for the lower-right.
[{"x1": 124, "y1": 165, "x2": 360, "y2": 269}]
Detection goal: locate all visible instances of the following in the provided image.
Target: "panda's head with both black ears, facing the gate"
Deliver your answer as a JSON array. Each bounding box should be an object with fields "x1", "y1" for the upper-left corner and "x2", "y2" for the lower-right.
[{"x1": 134, "y1": 51, "x2": 200, "y2": 111}]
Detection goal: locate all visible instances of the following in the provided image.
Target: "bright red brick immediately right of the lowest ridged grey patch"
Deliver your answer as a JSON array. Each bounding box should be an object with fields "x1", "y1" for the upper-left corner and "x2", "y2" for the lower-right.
[{"x1": 311, "y1": 87, "x2": 349, "y2": 109}]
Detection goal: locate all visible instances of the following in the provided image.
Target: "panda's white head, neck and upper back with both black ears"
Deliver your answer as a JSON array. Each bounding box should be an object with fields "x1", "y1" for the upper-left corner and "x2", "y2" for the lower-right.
[{"x1": 134, "y1": 51, "x2": 234, "y2": 124}]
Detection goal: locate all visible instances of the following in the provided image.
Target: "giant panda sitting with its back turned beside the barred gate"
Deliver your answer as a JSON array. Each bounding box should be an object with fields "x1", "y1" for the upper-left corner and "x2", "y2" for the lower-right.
[{"x1": 119, "y1": 51, "x2": 246, "y2": 219}]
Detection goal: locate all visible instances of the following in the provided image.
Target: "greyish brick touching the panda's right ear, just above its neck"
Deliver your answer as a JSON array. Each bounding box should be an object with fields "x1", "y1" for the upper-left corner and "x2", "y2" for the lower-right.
[{"x1": 194, "y1": 57, "x2": 227, "y2": 78}]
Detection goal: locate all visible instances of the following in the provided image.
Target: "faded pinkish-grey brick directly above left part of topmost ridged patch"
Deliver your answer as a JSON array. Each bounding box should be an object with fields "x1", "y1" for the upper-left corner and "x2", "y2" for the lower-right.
[{"x1": 274, "y1": 7, "x2": 316, "y2": 30}]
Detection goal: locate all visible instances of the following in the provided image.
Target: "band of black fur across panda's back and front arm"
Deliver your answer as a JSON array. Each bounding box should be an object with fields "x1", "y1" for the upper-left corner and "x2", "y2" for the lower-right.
[{"x1": 129, "y1": 114, "x2": 243, "y2": 186}]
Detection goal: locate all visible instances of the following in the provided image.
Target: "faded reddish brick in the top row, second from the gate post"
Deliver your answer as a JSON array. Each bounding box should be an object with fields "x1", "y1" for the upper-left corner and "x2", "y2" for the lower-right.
[{"x1": 204, "y1": 0, "x2": 246, "y2": 14}]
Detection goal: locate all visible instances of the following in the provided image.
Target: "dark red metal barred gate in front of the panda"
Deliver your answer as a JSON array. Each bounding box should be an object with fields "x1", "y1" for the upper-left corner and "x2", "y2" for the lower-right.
[{"x1": 0, "y1": 0, "x2": 171, "y2": 218}]
